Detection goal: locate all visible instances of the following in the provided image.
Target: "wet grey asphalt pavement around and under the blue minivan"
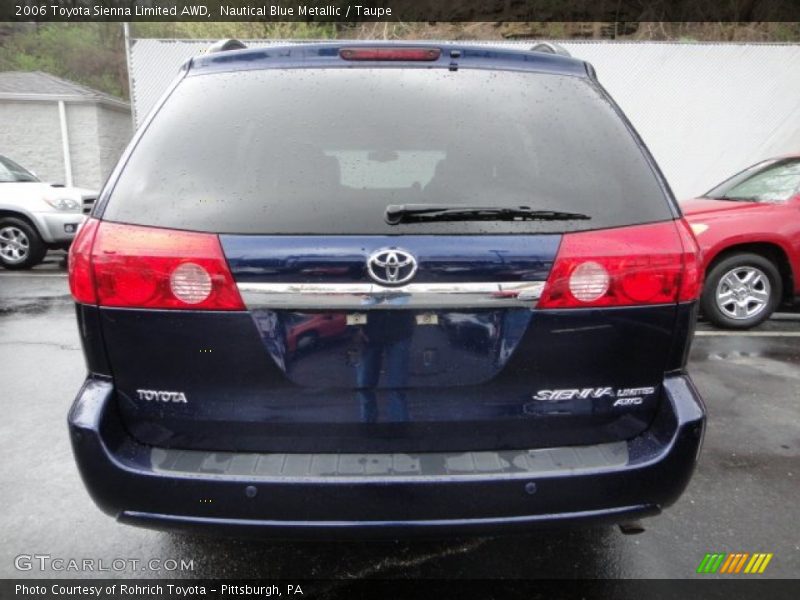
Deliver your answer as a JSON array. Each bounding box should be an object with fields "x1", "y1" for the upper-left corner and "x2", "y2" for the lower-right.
[{"x1": 0, "y1": 255, "x2": 800, "y2": 579}]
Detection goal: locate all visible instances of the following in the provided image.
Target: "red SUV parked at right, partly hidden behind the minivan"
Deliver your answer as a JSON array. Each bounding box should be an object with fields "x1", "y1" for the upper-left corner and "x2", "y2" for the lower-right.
[{"x1": 681, "y1": 155, "x2": 800, "y2": 329}]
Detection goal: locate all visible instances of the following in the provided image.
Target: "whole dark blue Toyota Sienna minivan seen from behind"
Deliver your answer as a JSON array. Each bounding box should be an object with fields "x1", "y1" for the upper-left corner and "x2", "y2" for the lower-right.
[{"x1": 69, "y1": 43, "x2": 705, "y2": 535}]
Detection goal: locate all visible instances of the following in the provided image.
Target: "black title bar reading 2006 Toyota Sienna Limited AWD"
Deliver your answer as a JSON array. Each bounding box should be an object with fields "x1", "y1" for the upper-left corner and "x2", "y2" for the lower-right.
[{"x1": 0, "y1": 0, "x2": 800, "y2": 23}]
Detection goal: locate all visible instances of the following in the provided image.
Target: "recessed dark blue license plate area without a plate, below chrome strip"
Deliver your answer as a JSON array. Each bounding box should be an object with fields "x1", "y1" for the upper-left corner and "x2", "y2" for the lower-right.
[{"x1": 253, "y1": 309, "x2": 532, "y2": 389}]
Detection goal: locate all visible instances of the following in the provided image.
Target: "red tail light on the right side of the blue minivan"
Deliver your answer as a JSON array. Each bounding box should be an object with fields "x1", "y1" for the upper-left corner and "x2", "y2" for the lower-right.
[{"x1": 538, "y1": 221, "x2": 700, "y2": 308}]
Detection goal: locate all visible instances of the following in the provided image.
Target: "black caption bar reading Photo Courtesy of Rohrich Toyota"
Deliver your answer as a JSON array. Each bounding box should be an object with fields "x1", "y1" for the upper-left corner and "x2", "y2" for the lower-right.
[{"x1": 0, "y1": 577, "x2": 800, "y2": 600}]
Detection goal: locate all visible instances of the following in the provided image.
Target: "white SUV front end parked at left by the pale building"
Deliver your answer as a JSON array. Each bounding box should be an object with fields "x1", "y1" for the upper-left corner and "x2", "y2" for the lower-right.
[{"x1": 0, "y1": 156, "x2": 97, "y2": 269}]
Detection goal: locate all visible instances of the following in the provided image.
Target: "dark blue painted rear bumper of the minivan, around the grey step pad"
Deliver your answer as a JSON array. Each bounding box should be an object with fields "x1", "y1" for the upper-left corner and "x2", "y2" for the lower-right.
[{"x1": 68, "y1": 375, "x2": 705, "y2": 538}]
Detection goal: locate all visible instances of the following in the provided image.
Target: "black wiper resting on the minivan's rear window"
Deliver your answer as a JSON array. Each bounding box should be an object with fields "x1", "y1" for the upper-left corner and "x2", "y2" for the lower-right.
[{"x1": 385, "y1": 204, "x2": 591, "y2": 225}]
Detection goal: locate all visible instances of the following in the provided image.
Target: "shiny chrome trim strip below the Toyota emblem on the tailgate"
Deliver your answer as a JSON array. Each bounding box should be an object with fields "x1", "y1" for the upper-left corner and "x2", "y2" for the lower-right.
[{"x1": 238, "y1": 281, "x2": 544, "y2": 310}]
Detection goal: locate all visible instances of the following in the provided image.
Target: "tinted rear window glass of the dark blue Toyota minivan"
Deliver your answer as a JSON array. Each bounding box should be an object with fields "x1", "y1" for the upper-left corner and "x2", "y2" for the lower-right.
[{"x1": 104, "y1": 68, "x2": 671, "y2": 234}]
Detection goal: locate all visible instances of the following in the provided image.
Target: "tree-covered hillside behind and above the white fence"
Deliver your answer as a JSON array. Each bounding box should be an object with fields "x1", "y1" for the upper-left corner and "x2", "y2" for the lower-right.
[{"x1": 0, "y1": 22, "x2": 800, "y2": 98}]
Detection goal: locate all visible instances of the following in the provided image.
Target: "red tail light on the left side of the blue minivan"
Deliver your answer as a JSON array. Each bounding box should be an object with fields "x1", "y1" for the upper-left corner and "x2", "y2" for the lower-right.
[{"x1": 70, "y1": 219, "x2": 244, "y2": 310}]
